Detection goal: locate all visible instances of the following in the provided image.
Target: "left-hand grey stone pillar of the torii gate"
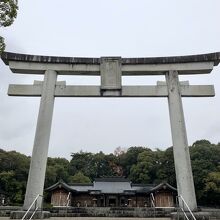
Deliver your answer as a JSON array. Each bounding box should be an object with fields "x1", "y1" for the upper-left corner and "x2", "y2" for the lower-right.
[{"x1": 23, "y1": 70, "x2": 57, "y2": 210}]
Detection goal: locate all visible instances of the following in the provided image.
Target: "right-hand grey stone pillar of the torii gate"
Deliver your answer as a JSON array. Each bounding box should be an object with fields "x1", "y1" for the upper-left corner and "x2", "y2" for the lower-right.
[{"x1": 166, "y1": 71, "x2": 197, "y2": 211}]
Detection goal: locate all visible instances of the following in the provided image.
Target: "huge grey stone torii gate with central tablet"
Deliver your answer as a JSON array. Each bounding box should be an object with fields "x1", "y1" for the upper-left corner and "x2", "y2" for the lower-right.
[{"x1": 1, "y1": 52, "x2": 220, "y2": 210}]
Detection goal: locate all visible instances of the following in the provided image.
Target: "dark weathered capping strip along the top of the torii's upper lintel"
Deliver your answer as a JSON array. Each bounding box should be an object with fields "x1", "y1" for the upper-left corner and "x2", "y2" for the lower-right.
[{"x1": 1, "y1": 52, "x2": 220, "y2": 65}]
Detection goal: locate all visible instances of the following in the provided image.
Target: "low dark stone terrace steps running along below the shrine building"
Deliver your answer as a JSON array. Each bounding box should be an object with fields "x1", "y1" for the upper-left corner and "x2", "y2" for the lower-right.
[{"x1": 0, "y1": 207, "x2": 220, "y2": 220}]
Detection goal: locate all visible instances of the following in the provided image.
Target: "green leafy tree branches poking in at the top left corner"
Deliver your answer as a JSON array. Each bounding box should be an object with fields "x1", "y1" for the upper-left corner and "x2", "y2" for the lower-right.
[{"x1": 0, "y1": 0, "x2": 18, "y2": 54}]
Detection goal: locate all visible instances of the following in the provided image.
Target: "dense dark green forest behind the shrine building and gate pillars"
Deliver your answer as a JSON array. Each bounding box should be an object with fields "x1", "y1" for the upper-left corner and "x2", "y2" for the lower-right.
[{"x1": 0, "y1": 140, "x2": 220, "y2": 206}]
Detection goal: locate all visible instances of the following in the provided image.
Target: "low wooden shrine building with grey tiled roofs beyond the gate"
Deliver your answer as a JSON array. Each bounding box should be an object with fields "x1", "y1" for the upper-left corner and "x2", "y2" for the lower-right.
[{"x1": 45, "y1": 177, "x2": 177, "y2": 207}]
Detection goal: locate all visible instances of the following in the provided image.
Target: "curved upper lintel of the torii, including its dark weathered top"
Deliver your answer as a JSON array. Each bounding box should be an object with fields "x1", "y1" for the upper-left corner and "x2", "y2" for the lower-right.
[{"x1": 1, "y1": 52, "x2": 220, "y2": 75}]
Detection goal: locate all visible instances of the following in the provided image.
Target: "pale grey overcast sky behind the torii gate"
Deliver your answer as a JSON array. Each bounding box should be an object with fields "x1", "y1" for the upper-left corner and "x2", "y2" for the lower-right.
[{"x1": 0, "y1": 0, "x2": 220, "y2": 159}]
